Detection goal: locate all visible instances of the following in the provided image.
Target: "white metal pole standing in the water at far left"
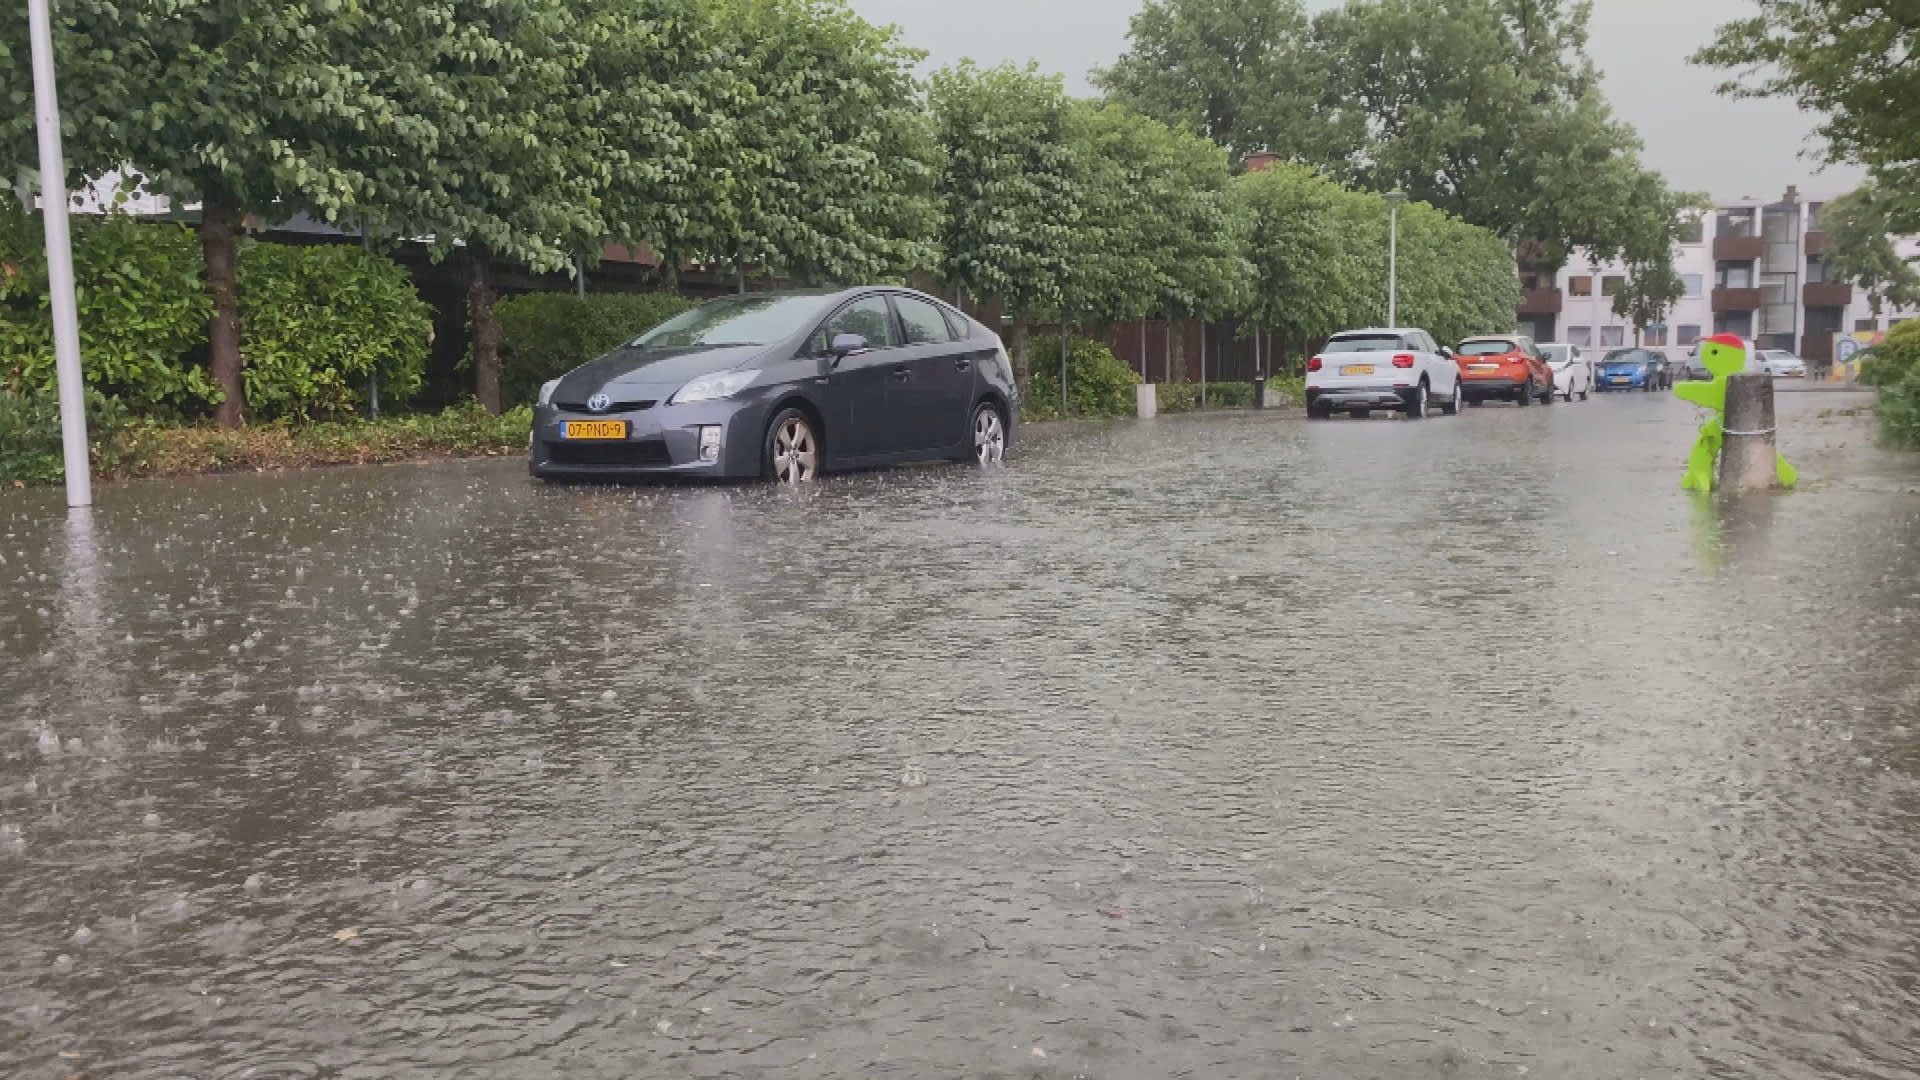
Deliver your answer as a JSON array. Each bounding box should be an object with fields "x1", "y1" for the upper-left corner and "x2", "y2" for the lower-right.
[{"x1": 27, "y1": 0, "x2": 94, "y2": 507}]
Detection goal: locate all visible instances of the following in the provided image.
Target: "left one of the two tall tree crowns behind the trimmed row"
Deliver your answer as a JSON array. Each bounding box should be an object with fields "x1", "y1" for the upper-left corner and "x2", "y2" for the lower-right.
[{"x1": 1094, "y1": 0, "x2": 1331, "y2": 160}]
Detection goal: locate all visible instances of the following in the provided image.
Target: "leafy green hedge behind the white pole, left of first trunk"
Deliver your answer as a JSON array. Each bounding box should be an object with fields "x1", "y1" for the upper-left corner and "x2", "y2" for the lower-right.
[{"x1": 0, "y1": 213, "x2": 219, "y2": 413}]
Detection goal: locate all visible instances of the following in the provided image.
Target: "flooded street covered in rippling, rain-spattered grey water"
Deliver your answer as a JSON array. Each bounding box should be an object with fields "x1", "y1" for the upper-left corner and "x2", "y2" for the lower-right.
[{"x1": 0, "y1": 394, "x2": 1920, "y2": 1080}]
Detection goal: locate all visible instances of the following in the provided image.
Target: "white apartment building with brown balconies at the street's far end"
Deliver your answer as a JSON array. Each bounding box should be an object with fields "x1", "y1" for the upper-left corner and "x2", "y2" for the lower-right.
[{"x1": 1519, "y1": 188, "x2": 1920, "y2": 365}]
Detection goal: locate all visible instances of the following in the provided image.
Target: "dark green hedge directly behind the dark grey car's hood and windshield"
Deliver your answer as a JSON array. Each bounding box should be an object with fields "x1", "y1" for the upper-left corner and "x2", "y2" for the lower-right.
[{"x1": 493, "y1": 292, "x2": 695, "y2": 405}]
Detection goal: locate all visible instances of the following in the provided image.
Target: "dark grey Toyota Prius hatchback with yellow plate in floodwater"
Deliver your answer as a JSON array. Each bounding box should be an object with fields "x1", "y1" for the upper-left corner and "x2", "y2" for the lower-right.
[{"x1": 528, "y1": 288, "x2": 1020, "y2": 484}]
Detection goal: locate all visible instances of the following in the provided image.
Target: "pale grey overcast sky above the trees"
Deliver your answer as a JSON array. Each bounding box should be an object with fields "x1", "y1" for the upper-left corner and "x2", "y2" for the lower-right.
[{"x1": 849, "y1": 0, "x2": 1857, "y2": 198}]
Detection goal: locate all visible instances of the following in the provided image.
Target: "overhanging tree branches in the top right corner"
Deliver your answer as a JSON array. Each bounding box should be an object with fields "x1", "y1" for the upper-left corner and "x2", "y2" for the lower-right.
[{"x1": 1693, "y1": 0, "x2": 1920, "y2": 214}]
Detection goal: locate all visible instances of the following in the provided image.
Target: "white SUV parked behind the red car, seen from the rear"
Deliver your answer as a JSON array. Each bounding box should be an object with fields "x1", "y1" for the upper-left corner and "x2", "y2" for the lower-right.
[{"x1": 1308, "y1": 329, "x2": 1465, "y2": 421}]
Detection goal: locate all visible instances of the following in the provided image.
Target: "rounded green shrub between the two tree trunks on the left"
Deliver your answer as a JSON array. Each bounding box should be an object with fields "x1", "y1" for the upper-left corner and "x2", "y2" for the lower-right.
[{"x1": 240, "y1": 240, "x2": 434, "y2": 421}]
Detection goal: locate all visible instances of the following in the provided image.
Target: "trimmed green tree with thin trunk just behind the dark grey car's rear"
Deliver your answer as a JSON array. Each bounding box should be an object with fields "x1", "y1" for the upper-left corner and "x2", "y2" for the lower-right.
[{"x1": 931, "y1": 61, "x2": 1083, "y2": 384}]
